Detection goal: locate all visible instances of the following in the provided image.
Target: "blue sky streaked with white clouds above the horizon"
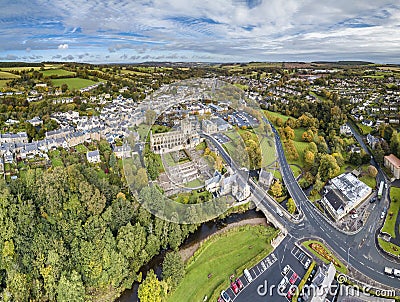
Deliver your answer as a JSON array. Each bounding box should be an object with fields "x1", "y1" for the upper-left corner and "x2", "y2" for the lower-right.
[{"x1": 0, "y1": 0, "x2": 400, "y2": 63}]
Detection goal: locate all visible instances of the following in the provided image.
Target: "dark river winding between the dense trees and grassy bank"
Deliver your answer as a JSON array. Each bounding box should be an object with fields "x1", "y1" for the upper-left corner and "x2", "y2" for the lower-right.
[{"x1": 116, "y1": 210, "x2": 265, "y2": 302}]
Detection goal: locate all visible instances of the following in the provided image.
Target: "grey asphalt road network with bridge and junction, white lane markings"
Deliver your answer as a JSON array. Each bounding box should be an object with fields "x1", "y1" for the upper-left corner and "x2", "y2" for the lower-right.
[{"x1": 203, "y1": 121, "x2": 400, "y2": 289}]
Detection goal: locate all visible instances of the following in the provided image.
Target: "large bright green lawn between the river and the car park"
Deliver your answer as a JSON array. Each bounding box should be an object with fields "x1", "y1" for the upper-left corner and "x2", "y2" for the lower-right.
[{"x1": 167, "y1": 226, "x2": 277, "y2": 302}]
